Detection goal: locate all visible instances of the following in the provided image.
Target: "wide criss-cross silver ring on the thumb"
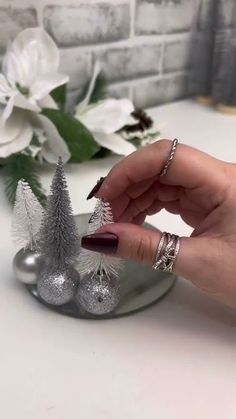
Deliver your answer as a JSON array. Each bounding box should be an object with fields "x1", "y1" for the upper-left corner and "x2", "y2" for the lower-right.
[{"x1": 152, "y1": 232, "x2": 180, "y2": 272}]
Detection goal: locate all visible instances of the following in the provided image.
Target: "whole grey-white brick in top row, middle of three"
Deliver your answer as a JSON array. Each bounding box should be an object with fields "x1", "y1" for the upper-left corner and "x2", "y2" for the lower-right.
[{"x1": 43, "y1": 1, "x2": 130, "y2": 47}]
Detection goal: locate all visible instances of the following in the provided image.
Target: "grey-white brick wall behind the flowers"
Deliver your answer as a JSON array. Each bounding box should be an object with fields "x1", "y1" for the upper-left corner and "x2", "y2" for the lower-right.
[{"x1": 0, "y1": 0, "x2": 225, "y2": 107}]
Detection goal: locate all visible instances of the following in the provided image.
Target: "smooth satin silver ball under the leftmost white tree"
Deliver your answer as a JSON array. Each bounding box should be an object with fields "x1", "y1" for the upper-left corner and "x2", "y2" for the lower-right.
[{"x1": 13, "y1": 249, "x2": 46, "y2": 284}]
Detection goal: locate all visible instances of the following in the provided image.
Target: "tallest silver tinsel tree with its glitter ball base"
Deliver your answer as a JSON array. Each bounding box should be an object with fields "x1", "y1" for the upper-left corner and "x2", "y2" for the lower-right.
[{"x1": 37, "y1": 158, "x2": 79, "y2": 305}]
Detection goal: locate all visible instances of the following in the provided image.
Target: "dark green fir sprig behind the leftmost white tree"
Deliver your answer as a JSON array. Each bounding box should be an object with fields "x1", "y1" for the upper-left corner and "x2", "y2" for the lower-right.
[{"x1": 2, "y1": 154, "x2": 47, "y2": 205}]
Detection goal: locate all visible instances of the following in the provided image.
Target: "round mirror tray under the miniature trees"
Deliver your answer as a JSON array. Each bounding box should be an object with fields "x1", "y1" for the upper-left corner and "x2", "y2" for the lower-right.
[{"x1": 26, "y1": 214, "x2": 176, "y2": 320}]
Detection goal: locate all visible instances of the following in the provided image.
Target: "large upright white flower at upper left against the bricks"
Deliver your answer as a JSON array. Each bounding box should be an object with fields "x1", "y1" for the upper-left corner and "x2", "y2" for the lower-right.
[{"x1": 0, "y1": 28, "x2": 68, "y2": 121}]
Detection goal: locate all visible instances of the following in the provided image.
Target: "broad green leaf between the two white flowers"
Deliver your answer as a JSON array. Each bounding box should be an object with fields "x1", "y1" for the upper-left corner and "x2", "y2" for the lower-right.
[{"x1": 42, "y1": 109, "x2": 99, "y2": 163}]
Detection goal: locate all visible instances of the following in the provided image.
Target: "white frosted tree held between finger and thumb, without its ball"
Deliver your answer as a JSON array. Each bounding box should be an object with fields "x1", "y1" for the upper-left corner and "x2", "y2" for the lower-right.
[{"x1": 78, "y1": 199, "x2": 121, "y2": 278}]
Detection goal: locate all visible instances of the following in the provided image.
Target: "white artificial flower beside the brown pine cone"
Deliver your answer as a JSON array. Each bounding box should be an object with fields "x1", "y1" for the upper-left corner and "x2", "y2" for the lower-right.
[{"x1": 75, "y1": 62, "x2": 136, "y2": 155}]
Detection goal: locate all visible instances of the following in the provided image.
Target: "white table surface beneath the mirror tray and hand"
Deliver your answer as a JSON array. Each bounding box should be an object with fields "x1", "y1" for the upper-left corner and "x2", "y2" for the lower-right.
[{"x1": 0, "y1": 101, "x2": 236, "y2": 419}]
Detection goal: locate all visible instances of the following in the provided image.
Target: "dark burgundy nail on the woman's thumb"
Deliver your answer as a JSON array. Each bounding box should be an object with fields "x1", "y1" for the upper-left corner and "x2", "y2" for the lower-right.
[{"x1": 81, "y1": 233, "x2": 119, "y2": 253}]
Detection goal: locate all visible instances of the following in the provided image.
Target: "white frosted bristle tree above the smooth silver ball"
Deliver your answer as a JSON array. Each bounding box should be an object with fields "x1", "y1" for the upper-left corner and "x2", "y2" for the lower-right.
[{"x1": 12, "y1": 179, "x2": 43, "y2": 250}]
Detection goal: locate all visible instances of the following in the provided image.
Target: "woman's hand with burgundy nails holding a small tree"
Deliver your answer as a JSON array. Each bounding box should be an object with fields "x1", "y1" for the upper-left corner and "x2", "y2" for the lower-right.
[{"x1": 82, "y1": 140, "x2": 236, "y2": 306}]
